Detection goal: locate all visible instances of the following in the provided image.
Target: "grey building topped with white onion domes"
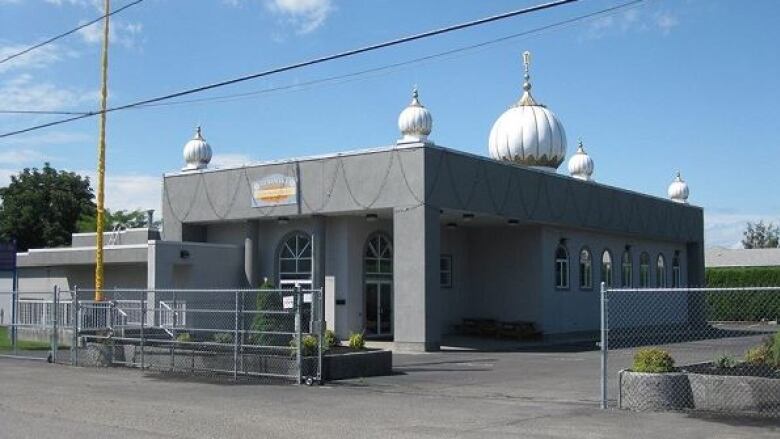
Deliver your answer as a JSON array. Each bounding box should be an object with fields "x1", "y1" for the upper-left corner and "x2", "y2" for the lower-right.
[{"x1": 6, "y1": 58, "x2": 704, "y2": 350}]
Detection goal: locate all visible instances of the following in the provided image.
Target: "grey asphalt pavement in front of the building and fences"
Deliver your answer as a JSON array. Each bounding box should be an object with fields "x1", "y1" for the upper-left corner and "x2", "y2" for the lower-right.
[{"x1": 0, "y1": 340, "x2": 780, "y2": 439}]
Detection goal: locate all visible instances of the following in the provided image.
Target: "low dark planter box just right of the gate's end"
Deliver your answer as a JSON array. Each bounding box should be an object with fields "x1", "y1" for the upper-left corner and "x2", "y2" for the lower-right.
[{"x1": 322, "y1": 350, "x2": 393, "y2": 380}]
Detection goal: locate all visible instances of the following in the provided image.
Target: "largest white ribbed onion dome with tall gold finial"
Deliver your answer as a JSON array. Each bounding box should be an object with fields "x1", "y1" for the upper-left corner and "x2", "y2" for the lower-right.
[{"x1": 488, "y1": 52, "x2": 566, "y2": 171}]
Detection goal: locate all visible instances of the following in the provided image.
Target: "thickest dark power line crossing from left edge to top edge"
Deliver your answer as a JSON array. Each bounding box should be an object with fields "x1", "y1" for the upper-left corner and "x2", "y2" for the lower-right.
[{"x1": 0, "y1": 0, "x2": 579, "y2": 138}]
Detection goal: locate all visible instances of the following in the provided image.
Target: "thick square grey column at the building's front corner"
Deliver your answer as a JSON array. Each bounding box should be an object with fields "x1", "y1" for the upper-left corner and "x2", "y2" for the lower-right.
[{"x1": 393, "y1": 206, "x2": 441, "y2": 351}]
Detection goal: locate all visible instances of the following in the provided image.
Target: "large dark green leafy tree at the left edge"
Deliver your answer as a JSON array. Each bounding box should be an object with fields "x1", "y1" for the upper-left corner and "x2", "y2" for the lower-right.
[{"x1": 0, "y1": 163, "x2": 95, "y2": 251}]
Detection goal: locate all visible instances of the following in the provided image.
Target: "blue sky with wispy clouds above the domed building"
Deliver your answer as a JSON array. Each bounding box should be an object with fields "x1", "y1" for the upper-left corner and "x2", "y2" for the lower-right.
[{"x1": 0, "y1": 0, "x2": 780, "y2": 246}]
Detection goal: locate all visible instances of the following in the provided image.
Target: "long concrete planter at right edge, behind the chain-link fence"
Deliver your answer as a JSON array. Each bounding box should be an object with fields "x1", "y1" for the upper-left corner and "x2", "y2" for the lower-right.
[{"x1": 688, "y1": 373, "x2": 780, "y2": 413}]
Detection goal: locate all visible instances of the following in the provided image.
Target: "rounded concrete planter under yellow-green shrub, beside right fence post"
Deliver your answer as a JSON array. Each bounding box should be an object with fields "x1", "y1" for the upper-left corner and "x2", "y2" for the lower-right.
[{"x1": 618, "y1": 370, "x2": 693, "y2": 411}]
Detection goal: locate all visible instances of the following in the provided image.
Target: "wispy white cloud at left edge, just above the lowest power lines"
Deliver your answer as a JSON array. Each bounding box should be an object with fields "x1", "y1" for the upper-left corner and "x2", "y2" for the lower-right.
[{"x1": 0, "y1": 73, "x2": 97, "y2": 111}]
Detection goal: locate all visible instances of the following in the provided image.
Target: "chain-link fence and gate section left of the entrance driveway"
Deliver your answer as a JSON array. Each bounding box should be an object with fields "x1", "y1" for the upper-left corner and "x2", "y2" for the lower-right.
[{"x1": 0, "y1": 287, "x2": 324, "y2": 384}]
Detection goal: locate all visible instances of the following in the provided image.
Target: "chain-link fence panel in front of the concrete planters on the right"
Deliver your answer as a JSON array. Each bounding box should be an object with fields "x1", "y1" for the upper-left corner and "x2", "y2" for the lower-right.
[{"x1": 601, "y1": 285, "x2": 780, "y2": 417}]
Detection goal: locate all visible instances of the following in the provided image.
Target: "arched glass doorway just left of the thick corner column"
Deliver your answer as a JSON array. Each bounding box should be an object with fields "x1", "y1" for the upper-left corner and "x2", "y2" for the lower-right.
[{"x1": 363, "y1": 233, "x2": 393, "y2": 337}]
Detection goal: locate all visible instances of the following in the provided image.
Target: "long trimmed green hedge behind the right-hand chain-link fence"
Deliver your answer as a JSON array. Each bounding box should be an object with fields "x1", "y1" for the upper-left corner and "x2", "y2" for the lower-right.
[{"x1": 706, "y1": 267, "x2": 780, "y2": 321}]
